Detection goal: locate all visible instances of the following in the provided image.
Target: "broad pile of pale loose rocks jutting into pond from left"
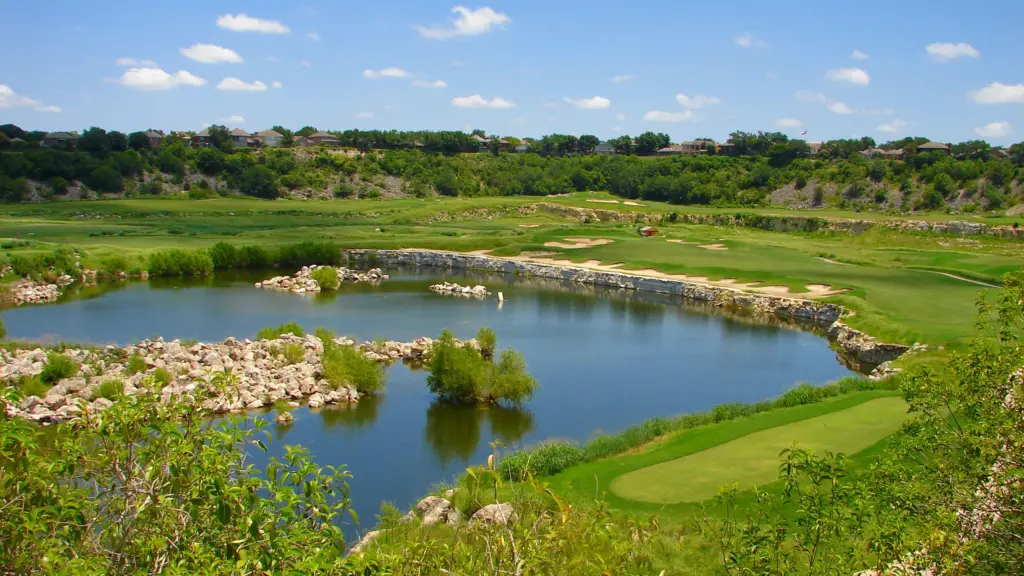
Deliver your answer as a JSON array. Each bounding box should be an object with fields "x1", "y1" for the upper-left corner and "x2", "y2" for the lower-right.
[{"x1": 0, "y1": 334, "x2": 479, "y2": 423}]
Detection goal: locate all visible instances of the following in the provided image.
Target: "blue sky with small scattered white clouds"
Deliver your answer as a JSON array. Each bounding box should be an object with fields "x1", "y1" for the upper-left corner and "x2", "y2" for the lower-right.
[{"x1": 0, "y1": 0, "x2": 1024, "y2": 145}]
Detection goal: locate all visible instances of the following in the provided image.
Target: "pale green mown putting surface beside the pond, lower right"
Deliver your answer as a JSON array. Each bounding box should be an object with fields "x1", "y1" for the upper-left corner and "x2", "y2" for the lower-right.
[{"x1": 611, "y1": 397, "x2": 908, "y2": 504}]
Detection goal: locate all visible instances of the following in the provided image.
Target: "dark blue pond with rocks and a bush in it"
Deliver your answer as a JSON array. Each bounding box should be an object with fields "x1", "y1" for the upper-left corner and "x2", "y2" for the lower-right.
[{"x1": 2, "y1": 271, "x2": 850, "y2": 529}]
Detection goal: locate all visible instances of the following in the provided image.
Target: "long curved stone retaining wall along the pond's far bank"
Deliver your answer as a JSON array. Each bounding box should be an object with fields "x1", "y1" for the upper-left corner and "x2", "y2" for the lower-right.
[{"x1": 346, "y1": 245, "x2": 907, "y2": 368}]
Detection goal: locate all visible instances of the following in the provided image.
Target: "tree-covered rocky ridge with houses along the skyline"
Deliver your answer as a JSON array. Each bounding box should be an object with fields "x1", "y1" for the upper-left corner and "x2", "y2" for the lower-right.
[{"x1": 0, "y1": 125, "x2": 1024, "y2": 211}]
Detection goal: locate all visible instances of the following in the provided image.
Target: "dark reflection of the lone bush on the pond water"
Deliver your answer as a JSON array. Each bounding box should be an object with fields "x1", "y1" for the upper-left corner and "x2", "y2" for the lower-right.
[{"x1": 423, "y1": 401, "x2": 534, "y2": 466}]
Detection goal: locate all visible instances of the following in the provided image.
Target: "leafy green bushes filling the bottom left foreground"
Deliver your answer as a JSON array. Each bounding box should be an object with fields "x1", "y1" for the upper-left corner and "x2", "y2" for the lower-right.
[{"x1": 0, "y1": 377, "x2": 360, "y2": 575}]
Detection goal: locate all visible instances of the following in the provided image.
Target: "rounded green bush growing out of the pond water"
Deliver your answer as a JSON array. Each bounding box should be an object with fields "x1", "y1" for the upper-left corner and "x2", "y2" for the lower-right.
[{"x1": 427, "y1": 330, "x2": 537, "y2": 404}]
